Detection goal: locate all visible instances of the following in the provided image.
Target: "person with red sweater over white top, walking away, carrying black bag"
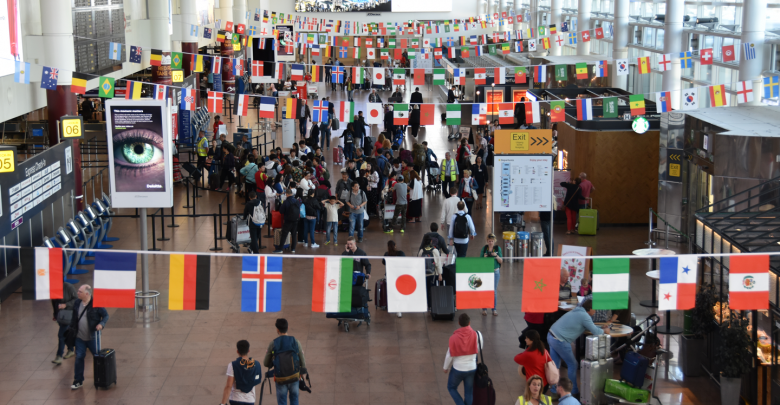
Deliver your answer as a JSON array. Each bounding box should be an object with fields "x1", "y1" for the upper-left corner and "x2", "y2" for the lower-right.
[{"x1": 444, "y1": 314, "x2": 485, "y2": 405}]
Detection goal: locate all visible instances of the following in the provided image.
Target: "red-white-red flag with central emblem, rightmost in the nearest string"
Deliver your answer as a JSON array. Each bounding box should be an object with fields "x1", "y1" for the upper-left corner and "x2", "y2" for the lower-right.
[{"x1": 729, "y1": 255, "x2": 769, "y2": 311}]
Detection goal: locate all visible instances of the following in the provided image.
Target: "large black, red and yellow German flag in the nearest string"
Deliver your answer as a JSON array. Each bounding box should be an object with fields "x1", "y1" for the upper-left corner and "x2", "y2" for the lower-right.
[{"x1": 168, "y1": 255, "x2": 211, "y2": 311}]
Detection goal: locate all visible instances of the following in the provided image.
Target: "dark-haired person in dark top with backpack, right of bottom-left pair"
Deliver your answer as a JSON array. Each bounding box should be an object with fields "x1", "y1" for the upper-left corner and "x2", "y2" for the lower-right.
[{"x1": 263, "y1": 318, "x2": 306, "y2": 405}]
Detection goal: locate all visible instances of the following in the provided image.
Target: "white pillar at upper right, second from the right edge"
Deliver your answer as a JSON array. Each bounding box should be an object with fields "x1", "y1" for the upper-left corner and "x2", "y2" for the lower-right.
[{"x1": 659, "y1": 0, "x2": 685, "y2": 110}]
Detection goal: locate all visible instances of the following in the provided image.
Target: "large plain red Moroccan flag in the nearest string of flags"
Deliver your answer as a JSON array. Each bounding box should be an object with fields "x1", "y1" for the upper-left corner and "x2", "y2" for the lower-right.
[{"x1": 521, "y1": 259, "x2": 561, "y2": 313}]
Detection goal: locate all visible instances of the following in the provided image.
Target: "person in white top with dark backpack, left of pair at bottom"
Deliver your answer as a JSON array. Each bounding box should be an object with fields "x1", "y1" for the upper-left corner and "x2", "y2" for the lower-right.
[{"x1": 219, "y1": 340, "x2": 263, "y2": 405}]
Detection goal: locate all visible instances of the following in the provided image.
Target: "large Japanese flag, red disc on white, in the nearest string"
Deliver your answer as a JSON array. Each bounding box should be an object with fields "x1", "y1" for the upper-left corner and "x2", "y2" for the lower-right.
[{"x1": 385, "y1": 257, "x2": 430, "y2": 312}]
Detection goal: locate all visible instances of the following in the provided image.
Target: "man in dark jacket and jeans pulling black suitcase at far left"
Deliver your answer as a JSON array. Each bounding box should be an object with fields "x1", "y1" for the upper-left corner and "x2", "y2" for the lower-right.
[{"x1": 70, "y1": 284, "x2": 108, "y2": 390}]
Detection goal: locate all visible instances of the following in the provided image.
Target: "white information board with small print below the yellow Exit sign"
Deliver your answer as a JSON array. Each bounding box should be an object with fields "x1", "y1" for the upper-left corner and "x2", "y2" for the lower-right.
[{"x1": 493, "y1": 155, "x2": 553, "y2": 212}]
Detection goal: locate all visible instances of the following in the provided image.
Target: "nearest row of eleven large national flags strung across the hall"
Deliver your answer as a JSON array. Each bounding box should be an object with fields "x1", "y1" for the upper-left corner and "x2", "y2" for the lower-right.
[{"x1": 20, "y1": 247, "x2": 769, "y2": 313}]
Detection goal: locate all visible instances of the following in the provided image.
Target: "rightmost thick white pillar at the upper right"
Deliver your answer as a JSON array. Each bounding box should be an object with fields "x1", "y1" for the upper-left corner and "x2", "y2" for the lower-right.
[{"x1": 739, "y1": 0, "x2": 774, "y2": 105}]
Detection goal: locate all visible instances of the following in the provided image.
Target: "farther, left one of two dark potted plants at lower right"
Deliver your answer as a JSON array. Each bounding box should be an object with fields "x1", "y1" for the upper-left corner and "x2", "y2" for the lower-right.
[{"x1": 680, "y1": 283, "x2": 718, "y2": 377}]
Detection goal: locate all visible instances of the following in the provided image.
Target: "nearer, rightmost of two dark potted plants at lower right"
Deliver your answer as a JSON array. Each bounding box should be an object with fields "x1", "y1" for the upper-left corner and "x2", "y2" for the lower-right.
[{"x1": 715, "y1": 311, "x2": 755, "y2": 405}]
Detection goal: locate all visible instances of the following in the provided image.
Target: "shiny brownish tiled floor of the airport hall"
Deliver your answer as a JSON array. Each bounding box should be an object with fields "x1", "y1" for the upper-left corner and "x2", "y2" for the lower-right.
[{"x1": 0, "y1": 80, "x2": 719, "y2": 405}]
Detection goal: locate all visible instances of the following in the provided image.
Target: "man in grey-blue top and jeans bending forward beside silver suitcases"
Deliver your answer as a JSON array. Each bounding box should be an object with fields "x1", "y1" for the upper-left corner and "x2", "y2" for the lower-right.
[{"x1": 547, "y1": 301, "x2": 609, "y2": 397}]
